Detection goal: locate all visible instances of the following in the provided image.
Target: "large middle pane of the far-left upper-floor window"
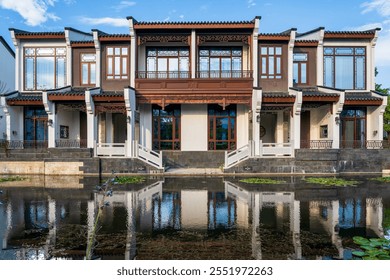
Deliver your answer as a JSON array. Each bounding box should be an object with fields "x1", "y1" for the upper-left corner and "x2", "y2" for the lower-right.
[{"x1": 36, "y1": 57, "x2": 55, "y2": 89}]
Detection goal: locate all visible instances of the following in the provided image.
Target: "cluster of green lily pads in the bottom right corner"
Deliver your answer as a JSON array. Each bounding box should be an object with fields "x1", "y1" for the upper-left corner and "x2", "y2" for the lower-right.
[{"x1": 352, "y1": 236, "x2": 390, "y2": 260}]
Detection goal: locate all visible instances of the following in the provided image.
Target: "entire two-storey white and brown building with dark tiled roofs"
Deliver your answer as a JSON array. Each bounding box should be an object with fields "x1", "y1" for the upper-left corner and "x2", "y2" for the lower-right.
[{"x1": 2, "y1": 17, "x2": 387, "y2": 171}]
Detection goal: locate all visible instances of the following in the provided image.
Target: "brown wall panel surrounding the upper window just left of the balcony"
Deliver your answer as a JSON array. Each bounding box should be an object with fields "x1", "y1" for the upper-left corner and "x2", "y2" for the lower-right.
[{"x1": 101, "y1": 42, "x2": 134, "y2": 91}]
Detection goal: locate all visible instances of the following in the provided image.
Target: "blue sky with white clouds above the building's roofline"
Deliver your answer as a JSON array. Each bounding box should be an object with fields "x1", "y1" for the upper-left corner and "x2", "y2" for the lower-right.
[{"x1": 0, "y1": 0, "x2": 390, "y2": 87}]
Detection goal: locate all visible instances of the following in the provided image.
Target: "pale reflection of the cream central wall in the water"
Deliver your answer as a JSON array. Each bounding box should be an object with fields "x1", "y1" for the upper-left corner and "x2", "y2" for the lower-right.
[{"x1": 181, "y1": 190, "x2": 208, "y2": 229}]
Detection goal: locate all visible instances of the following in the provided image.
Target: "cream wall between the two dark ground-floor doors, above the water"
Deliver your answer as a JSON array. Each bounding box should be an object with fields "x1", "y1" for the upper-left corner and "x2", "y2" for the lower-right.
[{"x1": 181, "y1": 104, "x2": 208, "y2": 151}]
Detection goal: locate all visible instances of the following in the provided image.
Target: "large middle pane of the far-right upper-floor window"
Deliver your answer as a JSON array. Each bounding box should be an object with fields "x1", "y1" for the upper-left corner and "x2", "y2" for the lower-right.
[{"x1": 335, "y1": 56, "x2": 354, "y2": 89}]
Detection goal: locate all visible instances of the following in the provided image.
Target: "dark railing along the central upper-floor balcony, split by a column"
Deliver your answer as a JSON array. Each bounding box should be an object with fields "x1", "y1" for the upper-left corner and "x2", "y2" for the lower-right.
[{"x1": 136, "y1": 70, "x2": 252, "y2": 79}]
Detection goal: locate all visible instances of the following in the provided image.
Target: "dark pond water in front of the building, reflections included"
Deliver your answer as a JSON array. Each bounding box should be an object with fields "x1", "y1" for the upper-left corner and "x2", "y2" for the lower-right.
[{"x1": 0, "y1": 176, "x2": 390, "y2": 260}]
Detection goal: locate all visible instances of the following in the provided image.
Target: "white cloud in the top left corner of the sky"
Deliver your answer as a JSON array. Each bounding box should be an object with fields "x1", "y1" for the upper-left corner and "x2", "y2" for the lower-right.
[{"x1": 0, "y1": 0, "x2": 60, "y2": 26}]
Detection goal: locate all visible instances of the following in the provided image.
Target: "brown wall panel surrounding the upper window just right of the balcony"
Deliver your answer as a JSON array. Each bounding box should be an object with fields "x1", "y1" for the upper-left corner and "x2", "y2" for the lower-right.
[{"x1": 258, "y1": 42, "x2": 288, "y2": 92}]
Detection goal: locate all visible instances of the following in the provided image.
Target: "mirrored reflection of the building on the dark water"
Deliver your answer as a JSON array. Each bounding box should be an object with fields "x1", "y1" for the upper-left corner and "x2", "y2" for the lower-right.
[{"x1": 0, "y1": 180, "x2": 383, "y2": 259}]
